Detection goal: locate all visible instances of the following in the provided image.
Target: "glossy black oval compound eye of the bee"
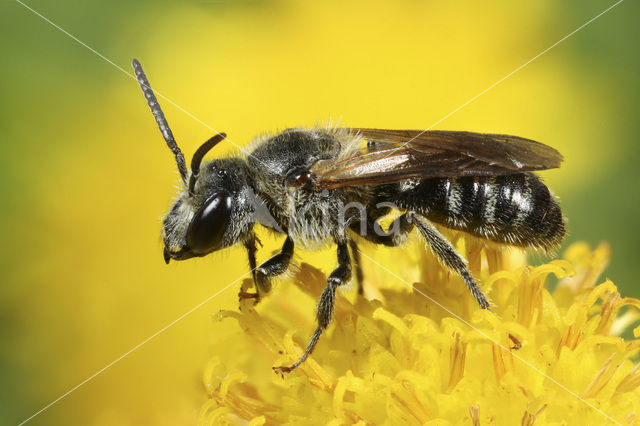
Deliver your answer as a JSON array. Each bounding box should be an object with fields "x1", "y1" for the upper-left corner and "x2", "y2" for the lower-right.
[{"x1": 187, "y1": 194, "x2": 231, "y2": 253}]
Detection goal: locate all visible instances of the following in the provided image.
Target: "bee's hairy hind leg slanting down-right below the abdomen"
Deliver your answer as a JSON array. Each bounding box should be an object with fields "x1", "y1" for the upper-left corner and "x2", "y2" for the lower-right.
[{"x1": 407, "y1": 212, "x2": 491, "y2": 310}]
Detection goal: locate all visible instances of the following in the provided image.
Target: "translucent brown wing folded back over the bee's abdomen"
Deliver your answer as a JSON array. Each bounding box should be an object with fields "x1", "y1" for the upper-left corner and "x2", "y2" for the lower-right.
[{"x1": 310, "y1": 129, "x2": 562, "y2": 189}]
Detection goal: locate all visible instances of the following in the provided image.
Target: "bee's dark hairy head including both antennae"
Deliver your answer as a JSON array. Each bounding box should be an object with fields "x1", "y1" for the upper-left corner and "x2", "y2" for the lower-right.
[{"x1": 133, "y1": 59, "x2": 253, "y2": 263}]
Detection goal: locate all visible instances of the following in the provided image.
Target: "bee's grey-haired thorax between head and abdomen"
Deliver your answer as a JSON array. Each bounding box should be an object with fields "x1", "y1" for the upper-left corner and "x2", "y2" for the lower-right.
[{"x1": 247, "y1": 128, "x2": 367, "y2": 249}]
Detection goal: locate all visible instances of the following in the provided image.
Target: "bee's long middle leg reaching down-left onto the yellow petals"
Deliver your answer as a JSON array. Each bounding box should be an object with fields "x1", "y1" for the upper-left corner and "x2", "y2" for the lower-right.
[{"x1": 273, "y1": 241, "x2": 351, "y2": 377}]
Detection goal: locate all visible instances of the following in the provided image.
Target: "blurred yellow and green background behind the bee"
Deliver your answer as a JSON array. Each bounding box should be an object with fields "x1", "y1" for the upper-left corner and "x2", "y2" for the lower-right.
[{"x1": 0, "y1": 0, "x2": 640, "y2": 425}]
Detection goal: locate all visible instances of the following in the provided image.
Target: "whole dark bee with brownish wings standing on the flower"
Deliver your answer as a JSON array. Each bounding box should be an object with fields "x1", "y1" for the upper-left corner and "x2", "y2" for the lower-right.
[{"x1": 133, "y1": 59, "x2": 566, "y2": 375}]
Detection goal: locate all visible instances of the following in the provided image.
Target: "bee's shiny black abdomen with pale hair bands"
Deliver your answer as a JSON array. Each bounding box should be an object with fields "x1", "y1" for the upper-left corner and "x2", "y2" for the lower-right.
[{"x1": 398, "y1": 173, "x2": 565, "y2": 248}]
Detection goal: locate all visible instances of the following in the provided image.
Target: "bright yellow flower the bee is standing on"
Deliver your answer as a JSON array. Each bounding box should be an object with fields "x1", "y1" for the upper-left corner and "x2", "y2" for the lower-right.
[{"x1": 199, "y1": 238, "x2": 640, "y2": 425}]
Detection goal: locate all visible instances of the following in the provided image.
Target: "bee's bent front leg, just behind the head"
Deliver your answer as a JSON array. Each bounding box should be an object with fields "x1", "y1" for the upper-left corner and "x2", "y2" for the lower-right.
[{"x1": 239, "y1": 236, "x2": 294, "y2": 302}]
